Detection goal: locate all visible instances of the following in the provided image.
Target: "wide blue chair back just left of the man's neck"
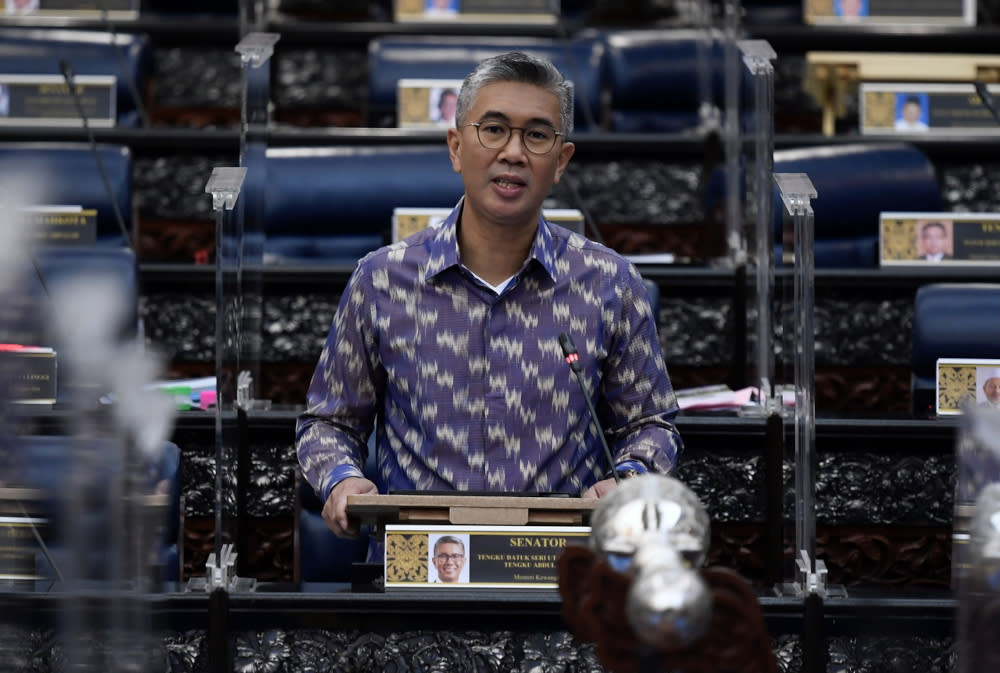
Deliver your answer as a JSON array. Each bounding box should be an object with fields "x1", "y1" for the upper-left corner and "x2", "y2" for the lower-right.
[{"x1": 264, "y1": 142, "x2": 463, "y2": 265}]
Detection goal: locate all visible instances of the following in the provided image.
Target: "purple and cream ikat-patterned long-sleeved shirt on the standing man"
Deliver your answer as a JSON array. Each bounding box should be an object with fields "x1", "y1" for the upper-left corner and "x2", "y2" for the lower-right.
[{"x1": 296, "y1": 201, "x2": 682, "y2": 501}]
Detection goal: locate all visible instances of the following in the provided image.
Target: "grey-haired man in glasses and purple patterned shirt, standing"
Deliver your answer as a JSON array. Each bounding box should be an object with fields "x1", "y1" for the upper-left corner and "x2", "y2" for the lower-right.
[{"x1": 296, "y1": 52, "x2": 681, "y2": 536}]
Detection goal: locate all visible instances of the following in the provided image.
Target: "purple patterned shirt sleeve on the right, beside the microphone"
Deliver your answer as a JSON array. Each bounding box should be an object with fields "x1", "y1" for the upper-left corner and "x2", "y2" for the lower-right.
[{"x1": 601, "y1": 264, "x2": 683, "y2": 474}]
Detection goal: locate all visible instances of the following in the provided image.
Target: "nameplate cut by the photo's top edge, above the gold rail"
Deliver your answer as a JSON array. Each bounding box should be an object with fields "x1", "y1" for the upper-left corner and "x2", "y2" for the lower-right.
[{"x1": 802, "y1": 0, "x2": 976, "y2": 26}]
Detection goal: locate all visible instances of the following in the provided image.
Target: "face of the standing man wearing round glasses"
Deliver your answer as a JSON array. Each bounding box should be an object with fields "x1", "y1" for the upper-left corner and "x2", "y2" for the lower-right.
[{"x1": 448, "y1": 82, "x2": 574, "y2": 232}]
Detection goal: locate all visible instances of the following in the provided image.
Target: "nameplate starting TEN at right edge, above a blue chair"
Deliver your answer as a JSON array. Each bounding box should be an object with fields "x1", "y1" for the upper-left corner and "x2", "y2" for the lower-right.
[{"x1": 879, "y1": 212, "x2": 1000, "y2": 266}]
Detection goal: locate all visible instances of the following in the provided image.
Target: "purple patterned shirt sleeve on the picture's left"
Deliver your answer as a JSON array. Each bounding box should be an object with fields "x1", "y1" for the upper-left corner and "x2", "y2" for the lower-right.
[{"x1": 295, "y1": 262, "x2": 385, "y2": 502}]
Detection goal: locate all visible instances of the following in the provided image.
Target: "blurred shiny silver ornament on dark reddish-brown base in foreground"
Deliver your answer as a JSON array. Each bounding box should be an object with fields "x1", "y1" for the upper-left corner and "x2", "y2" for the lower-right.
[{"x1": 559, "y1": 474, "x2": 777, "y2": 673}]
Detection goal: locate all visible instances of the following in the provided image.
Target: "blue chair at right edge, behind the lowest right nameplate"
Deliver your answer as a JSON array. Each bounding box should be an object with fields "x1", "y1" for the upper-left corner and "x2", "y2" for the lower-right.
[{"x1": 911, "y1": 283, "x2": 1000, "y2": 416}]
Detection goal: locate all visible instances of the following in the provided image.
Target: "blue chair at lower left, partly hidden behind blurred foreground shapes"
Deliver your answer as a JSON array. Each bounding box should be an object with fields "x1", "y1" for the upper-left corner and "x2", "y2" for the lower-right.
[{"x1": 0, "y1": 435, "x2": 181, "y2": 581}]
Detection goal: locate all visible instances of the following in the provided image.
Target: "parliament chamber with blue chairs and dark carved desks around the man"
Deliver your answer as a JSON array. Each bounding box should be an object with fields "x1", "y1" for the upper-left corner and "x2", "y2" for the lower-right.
[{"x1": 0, "y1": 0, "x2": 1000, "y2": 673}]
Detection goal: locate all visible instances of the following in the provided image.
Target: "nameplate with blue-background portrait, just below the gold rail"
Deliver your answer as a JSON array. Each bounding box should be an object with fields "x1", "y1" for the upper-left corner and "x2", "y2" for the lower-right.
[{"x1": 858, "y1": 82, "x2": 1000, "y2": 136}]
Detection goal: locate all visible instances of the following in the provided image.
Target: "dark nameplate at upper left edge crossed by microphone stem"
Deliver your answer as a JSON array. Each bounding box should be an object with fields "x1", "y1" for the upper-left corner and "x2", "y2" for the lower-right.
[{"x1": 0, "y1": 75, "x2": 117, "y2": 128}]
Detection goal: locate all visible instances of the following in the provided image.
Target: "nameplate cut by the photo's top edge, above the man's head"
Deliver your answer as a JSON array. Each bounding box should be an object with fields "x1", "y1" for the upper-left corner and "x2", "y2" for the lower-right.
[{"x1": 394, "y1": 0, "x2": 559, "y2": 24}]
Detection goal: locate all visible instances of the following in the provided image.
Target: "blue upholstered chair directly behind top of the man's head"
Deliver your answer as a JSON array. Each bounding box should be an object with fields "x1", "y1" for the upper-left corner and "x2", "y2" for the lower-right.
[{"x1": 367, "y1": 34, "x2": 604, "y2": 130}]
